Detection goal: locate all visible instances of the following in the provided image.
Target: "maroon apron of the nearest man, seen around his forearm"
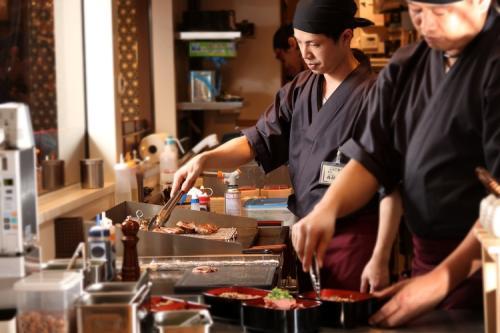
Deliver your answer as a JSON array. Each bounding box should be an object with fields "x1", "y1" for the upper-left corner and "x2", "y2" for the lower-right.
[{"x1": 412, "y1": 236, "x2": 483, "y2": 310}]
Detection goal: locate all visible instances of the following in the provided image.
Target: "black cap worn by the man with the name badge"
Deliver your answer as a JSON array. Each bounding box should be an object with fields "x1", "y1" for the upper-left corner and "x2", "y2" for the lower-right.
[{"x1": 293, "y1": 0, "x2": 373, "y2": 34}]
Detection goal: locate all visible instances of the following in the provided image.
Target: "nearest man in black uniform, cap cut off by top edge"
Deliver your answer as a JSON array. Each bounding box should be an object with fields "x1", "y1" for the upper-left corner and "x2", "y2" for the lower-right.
[{"x1": 292, "y1": 0, "x2": 500, "y2": 326}]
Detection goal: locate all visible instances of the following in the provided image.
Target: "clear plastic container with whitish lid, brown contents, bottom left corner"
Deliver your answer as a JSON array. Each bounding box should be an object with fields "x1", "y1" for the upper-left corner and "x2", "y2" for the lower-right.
[{"x1": 14, "y1": 271, "x2": 82, "y2": 333}]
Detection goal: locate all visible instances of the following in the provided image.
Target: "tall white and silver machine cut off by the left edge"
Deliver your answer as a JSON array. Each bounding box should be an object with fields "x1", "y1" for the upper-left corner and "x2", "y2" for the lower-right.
[{"x1": 0, "y1": 103, "x2": 40, "y2": 315}]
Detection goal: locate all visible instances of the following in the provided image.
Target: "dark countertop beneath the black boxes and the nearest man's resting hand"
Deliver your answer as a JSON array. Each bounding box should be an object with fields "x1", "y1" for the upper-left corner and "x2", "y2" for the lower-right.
[{"x1": 211, "y1": 310, "x2": 484, "y2": 333}]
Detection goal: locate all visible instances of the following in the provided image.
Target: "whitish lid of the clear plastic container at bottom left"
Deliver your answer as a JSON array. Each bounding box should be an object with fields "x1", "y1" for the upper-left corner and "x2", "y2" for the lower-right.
[{"x1": 14, "y1": 271, "x2": 82, "y2": 291}]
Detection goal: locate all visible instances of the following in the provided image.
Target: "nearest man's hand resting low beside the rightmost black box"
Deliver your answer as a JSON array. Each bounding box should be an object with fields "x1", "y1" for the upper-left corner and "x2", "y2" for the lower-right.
[{"x1": 369, "y1": 270, "x2": 447, "y2": 327}]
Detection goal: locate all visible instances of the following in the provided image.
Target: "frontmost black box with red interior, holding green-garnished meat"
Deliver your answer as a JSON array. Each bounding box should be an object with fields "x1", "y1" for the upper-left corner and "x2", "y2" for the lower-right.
[{"x1": 241, "y1": 298, "x2": 321, "y2": 333}]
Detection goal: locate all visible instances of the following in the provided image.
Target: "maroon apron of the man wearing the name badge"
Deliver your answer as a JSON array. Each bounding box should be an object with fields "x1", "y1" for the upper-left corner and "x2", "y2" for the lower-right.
[{"x1": 321, "y1": 213, "x2": 378, "y2": 291}]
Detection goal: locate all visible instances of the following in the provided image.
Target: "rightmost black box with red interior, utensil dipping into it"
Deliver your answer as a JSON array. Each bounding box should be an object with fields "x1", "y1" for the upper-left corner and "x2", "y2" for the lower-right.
[{"x1": 298, "y1": 289, "x2": 380, "y2": 328}]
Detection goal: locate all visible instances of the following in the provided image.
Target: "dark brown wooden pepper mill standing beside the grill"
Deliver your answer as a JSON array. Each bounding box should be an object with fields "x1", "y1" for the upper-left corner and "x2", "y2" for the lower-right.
[{"x1": 122, "y1": 216, "x2": 141, "y2": 281}]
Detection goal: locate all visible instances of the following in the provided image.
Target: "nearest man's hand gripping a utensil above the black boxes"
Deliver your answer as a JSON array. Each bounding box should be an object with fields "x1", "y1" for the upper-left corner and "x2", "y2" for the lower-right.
[{"x1": 292, "y1": 206, "x2": 335, "y2": 272}]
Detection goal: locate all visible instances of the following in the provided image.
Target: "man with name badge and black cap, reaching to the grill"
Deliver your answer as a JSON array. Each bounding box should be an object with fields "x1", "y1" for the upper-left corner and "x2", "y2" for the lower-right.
[{"x1": 172, "y1": 0, "x2": 400, "y2": 290}]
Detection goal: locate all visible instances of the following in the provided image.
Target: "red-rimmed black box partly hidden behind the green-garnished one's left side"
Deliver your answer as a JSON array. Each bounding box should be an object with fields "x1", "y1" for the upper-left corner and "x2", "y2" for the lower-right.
[{"x1": 203, "y1": 286, "x2": 269, "y2": 324}]
